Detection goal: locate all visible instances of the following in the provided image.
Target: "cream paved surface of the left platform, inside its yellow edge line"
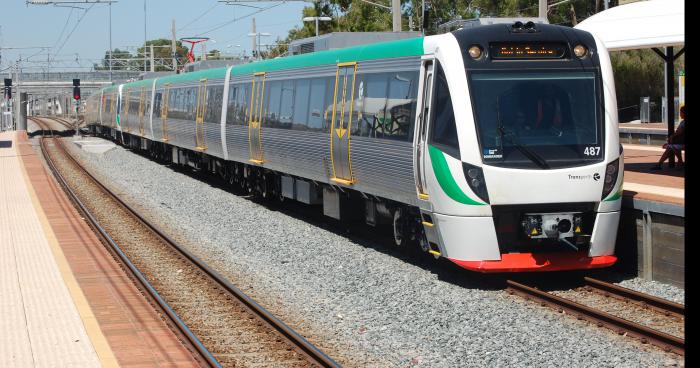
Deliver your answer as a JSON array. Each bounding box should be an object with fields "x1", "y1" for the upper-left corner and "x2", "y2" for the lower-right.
[{"x1": 0, "y1": 132, "x2": 101, "y2": 367}]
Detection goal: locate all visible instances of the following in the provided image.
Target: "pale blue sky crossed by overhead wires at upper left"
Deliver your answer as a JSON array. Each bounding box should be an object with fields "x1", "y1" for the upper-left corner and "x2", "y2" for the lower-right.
[{"x1": 0, "y1": 0, "x2": 308, "y2": 74}]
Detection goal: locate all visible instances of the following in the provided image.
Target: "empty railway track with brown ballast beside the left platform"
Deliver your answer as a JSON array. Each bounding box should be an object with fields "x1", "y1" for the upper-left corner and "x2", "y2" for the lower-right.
[{"x1": 35, "y1": 119, "x2": 338, "y2": 367}]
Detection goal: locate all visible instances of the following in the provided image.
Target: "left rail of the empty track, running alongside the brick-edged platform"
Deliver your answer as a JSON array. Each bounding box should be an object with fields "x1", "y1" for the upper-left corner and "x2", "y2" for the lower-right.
[{"x1": 32, "y1": 119, "x2": 221, "y2": 367}]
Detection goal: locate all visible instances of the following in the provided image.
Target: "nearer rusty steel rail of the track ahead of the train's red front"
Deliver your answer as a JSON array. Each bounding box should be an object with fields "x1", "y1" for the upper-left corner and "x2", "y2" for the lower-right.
[{"x1": 506, "y1": 280, "x2": 685, "y2": 355}]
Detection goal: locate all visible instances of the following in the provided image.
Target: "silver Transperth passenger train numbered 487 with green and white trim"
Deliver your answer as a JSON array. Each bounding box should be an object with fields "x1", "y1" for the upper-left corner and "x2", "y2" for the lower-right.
[{"x1": 86, "y1": 22, "x2": 623, "y2": 272}]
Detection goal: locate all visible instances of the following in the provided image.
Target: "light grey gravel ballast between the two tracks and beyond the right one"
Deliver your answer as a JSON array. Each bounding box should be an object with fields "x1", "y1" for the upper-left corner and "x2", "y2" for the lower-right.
[{"x1": 61, "y1": 136, "x2": 684, "y2": 367}]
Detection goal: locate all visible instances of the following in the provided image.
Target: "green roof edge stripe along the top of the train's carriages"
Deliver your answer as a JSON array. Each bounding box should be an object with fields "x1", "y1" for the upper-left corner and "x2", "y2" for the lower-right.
[{"x1": 109, "y1": 37, "x2": 424, "y2": 92}]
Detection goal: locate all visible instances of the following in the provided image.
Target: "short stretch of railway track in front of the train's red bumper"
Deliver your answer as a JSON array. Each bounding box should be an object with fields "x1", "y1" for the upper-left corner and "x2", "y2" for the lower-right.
[{"x1": 507, "y1": 277, "x2": 685, "y2": 355}]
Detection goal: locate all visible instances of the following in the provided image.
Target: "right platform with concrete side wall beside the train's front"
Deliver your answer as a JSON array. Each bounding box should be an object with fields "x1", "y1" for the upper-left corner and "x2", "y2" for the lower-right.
[{"x1": 615, "y1": 142, "x2": 685, "y2": 288}]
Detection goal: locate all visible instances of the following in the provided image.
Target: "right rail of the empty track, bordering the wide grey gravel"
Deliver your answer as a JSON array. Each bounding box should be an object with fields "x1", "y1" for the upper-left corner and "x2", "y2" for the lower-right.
[{"x1": 36, "y1": 118, "x2": 340, "y2": 367}]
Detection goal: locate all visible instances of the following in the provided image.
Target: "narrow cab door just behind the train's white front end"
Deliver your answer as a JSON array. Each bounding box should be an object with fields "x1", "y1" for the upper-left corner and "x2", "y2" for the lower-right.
[{"x1": 413, "y1": 58, "x2": 434, "y2": 201}]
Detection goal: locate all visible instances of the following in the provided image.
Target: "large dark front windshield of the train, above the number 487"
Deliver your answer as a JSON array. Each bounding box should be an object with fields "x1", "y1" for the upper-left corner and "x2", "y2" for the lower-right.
[{"x1": 470, "y1": 70, "x2": 603, "y2": 169}]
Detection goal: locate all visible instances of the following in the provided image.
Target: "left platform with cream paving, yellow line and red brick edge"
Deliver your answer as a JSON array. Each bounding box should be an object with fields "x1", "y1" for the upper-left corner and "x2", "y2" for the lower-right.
[{"x1": 0, "y1": 131, "x2": 199, "y2": 367}]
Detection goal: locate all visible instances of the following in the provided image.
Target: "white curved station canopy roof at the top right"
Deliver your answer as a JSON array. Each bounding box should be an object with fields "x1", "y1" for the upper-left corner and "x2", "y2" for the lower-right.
[{"x1": 575, "y1": 0, "x2": 685, "y2": 51}]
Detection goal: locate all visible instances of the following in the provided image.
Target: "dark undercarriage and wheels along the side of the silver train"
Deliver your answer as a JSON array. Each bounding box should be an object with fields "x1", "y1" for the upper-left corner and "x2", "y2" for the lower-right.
[{"x1": 89, "y1": 125, "x2": 426, "y2": 253}]
